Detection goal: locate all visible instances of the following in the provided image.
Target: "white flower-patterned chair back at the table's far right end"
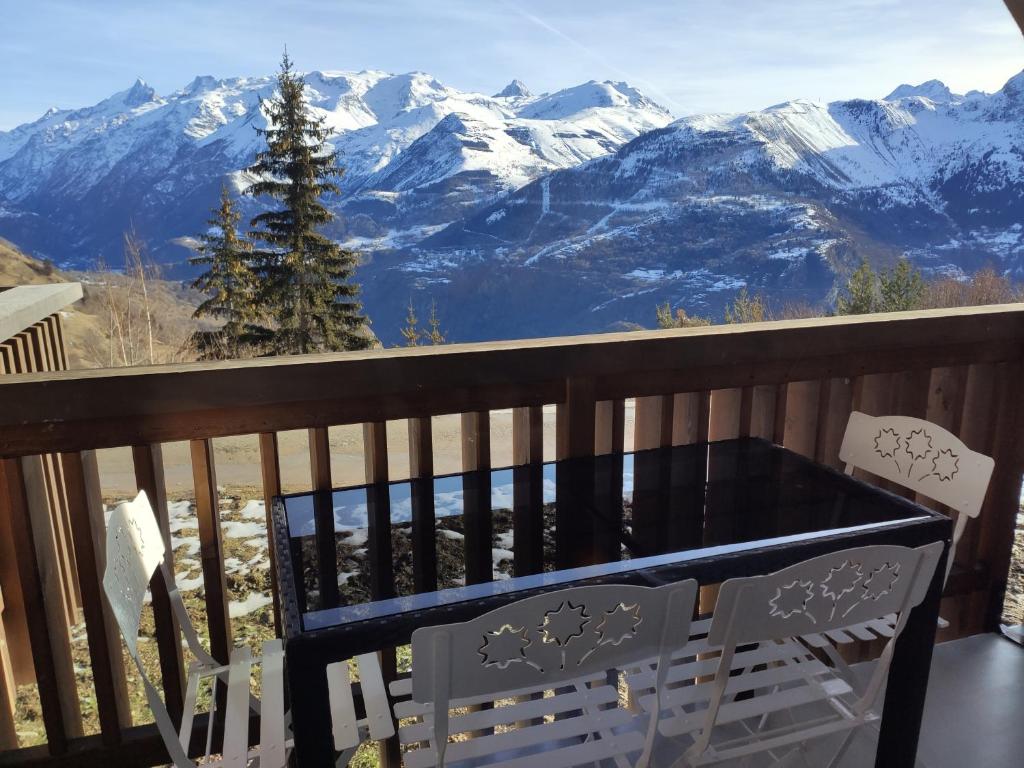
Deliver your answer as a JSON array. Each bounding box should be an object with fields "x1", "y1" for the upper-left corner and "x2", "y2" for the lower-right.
[{"x1": 839, "y1": 411, "x2": 995, "y2": 579}]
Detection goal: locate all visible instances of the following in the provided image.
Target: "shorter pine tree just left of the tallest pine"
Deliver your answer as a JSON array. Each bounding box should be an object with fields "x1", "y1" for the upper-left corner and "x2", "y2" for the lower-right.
[{"x1": 188, "y1": 186, "x2": 256, "y2": 359}]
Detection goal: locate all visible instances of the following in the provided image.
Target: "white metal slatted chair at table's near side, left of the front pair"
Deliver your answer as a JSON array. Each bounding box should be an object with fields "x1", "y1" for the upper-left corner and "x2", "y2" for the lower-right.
[{"x1": 329, "y1": 581, "x2": 697, "y2": 768}]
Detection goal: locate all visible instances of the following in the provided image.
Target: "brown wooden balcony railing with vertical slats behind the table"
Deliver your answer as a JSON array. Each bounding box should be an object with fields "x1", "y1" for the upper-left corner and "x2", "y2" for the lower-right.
[{"x1": 0, "y1": 304, "x2": 1024, "y2": 765}]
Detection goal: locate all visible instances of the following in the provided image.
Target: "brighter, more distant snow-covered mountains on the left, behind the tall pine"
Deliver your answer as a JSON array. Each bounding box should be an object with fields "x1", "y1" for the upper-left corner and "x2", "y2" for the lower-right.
[{"x1": 0, "y1": 72, "x2": 672, "y2": 263}]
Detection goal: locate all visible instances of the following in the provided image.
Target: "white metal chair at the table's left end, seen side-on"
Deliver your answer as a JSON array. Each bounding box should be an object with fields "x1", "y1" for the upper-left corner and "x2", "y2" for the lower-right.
[{"x1": 103, "y1": 493, "x2": 291, "y2": 768}]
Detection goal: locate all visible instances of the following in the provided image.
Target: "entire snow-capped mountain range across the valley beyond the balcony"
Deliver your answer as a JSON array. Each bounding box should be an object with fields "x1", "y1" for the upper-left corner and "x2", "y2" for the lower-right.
[{"x1": 0, "y1": 72, "x2": 1024, "y2": 342}]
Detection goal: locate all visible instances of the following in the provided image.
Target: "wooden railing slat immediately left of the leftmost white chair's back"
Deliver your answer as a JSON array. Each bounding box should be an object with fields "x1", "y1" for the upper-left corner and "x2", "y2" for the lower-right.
[{"x1": 61, "y1": 451, "x2": 131, "y2": 744}]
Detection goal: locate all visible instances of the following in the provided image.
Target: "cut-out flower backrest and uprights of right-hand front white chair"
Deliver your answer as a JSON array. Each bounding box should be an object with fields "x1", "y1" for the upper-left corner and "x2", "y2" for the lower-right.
[{"x1": 688, "y1": 542, "x2": 944, "y2": 758}]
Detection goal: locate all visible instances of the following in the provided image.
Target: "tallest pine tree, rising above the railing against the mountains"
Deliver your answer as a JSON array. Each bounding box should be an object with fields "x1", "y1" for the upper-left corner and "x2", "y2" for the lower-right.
[{"x1": 248, "y1": 50, "x2": 373, "y2": 354}]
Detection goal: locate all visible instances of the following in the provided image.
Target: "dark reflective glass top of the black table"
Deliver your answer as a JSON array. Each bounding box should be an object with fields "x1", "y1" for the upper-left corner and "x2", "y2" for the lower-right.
[{"x1": 278, "y1": 439, "x2": 929, "y2": 632}]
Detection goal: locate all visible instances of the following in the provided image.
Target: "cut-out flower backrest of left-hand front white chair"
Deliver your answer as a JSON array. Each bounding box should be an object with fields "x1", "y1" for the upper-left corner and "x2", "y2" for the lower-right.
[{"x1": 413, "y1": 580, "x2": 697, "y2": 766}]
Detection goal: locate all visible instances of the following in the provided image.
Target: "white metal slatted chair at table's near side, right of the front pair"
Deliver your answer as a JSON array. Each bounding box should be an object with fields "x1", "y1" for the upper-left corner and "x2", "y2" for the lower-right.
[{"x1": 628, "y1": 542, "x2": 943, "y2": 766}]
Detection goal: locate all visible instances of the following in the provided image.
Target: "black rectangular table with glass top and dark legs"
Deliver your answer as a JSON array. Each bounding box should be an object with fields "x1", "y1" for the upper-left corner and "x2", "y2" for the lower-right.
[{"x1": 272, "y1": 438, "x2": 951, "y2": 767}]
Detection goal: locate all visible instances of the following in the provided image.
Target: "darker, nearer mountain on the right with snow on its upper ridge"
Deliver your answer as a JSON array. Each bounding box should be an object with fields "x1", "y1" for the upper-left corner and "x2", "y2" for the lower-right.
[{"x1": 358, "y1": 73, "x2": 1024, "y2": 338}]
